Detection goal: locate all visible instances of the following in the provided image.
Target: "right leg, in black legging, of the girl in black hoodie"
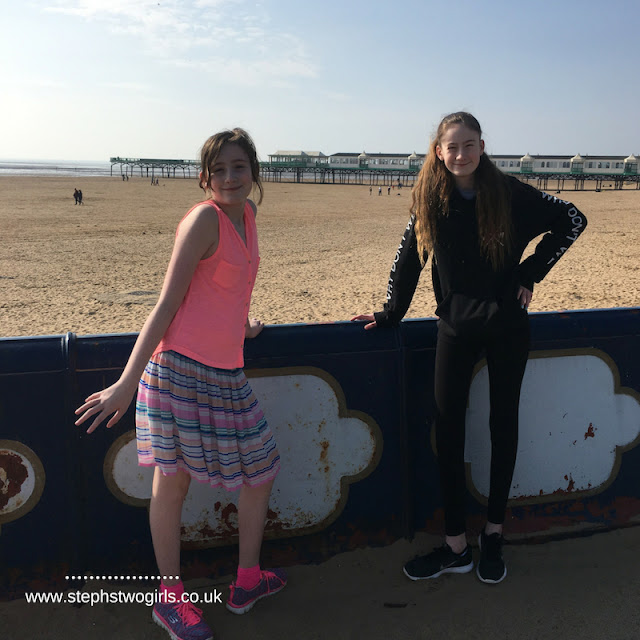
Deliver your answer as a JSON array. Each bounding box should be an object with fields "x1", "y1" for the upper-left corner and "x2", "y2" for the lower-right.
[{"x1": 486, "y1": 317, "x2": 529, "y2": 524}]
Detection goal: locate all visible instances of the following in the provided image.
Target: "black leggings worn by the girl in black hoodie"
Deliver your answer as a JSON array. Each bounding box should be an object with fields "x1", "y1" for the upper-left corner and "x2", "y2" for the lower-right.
[{"x1": 435, "y1": 308, "x2": 529, "y2": 536}]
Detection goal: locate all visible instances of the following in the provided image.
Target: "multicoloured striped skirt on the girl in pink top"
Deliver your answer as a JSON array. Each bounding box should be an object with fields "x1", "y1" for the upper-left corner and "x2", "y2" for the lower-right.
[{"x1": 136, "y1": 351, "x2": 280, "y2": 490}]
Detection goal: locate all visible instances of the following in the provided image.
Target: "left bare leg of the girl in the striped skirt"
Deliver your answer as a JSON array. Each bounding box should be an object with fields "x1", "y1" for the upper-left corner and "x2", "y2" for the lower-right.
[{"x1": 149, "y1": 467, "x2": 191, "y2": 586}]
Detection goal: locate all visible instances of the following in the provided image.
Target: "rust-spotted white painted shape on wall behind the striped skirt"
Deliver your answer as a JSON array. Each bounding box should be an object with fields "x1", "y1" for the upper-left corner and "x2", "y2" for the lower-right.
[{"x1": 107, "y1": 374, "x2": 376, "y2": 541}]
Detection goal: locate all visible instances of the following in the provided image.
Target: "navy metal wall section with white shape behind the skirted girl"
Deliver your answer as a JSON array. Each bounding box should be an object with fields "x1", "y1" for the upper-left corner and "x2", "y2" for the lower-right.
[{"x1": 72, "y1": 323, "x2": 408, "y2": 573}]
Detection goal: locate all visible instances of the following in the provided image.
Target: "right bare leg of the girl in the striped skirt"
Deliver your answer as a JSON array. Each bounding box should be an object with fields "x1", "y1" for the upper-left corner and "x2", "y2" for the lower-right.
[{"x1": 238, "y1": 480, "x2": 273, "y2": 569}]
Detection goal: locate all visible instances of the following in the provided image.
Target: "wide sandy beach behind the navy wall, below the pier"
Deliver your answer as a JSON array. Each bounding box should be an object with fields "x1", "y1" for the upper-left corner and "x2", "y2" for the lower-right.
[{"x1": 0, "y1": 172, "x2": 640, "y2": 337}]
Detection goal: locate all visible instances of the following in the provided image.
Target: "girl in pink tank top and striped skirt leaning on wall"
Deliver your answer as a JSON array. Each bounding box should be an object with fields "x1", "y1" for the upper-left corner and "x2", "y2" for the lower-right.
[{"x1": 76, "y1": 129, "x2": 287, "y2": 640}]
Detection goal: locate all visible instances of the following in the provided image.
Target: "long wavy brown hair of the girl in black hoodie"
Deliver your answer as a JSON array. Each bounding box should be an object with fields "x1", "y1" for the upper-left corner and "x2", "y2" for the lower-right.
[{"x1": 411, "y1": 111, "x2": 512, "y2": 271}]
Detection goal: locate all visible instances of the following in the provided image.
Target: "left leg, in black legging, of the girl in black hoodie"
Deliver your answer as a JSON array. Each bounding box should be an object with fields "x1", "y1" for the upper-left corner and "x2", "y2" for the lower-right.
[{"x1": 435, "y1": 322, "x2": 480, "y2": 553}]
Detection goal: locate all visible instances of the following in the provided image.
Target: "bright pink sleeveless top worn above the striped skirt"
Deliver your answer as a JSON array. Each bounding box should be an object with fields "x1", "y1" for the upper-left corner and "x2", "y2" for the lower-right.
[{"x1": 154, "y1": 200, "x2": 260, "y2": 369}]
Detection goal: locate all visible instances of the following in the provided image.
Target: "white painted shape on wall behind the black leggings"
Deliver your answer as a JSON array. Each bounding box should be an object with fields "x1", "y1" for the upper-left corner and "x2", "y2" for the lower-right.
[{"x1": 465, "y1": 355, "x2": 640, "y2": 498}]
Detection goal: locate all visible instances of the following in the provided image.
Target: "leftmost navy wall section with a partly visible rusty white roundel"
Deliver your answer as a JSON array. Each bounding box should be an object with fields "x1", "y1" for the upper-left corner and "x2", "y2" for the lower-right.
[{"x1": 0, "y1": 336, "x2": 79, "y2": 598}]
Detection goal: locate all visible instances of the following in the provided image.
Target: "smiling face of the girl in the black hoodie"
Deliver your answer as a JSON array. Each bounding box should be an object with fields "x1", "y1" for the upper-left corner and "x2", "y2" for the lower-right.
[{"x1": 436, "y1": 124, "x2": 484, "y2": 189}]
